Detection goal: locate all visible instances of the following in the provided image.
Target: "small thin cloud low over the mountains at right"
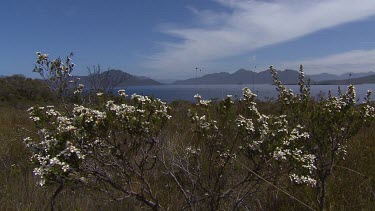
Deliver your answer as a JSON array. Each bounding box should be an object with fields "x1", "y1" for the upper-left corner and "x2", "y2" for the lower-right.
[{"x1": 278, "y1": 49, "x2": 375, "y2": 74}]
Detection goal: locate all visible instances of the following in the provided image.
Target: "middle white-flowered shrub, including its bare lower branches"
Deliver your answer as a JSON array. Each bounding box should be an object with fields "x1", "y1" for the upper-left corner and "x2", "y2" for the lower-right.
[{"x1": 166, "y1": 88, "x2": 316, "y2": 210}]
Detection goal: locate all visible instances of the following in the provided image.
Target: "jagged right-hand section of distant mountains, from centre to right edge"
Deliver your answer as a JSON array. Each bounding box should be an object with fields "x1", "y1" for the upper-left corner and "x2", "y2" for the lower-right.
[{"x1": 174, "y1": 69, "x2": 375, "y2": 85}]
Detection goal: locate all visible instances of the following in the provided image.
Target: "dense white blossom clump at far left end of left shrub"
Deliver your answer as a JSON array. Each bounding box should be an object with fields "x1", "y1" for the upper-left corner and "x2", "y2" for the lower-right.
[{"x1": 24, "y1": 106, "x2": 98, "y2": 185}]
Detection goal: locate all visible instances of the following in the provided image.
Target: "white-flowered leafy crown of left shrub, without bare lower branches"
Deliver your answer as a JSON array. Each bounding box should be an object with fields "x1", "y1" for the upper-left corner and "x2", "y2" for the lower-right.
[{"x1": 24, "y1": 92, "x2": 170, "y2": 185}]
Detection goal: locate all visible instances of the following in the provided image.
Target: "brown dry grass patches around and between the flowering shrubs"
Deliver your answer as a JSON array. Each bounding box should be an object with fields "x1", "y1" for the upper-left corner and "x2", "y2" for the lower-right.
[{"x1": 0, "y1": 102, "x2": 375, "y2": 210}]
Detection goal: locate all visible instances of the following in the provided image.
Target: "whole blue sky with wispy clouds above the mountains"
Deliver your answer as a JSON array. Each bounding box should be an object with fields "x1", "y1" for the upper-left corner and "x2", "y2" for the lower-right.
[{"x1": 0, "y1": 0, "x2": 375, "y2": 79}]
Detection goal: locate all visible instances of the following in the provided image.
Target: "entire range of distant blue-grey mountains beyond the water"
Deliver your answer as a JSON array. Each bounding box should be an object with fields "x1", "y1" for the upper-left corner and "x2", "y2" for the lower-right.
[{"x1": 5, "y1": 69, "x2": 375, "y2": 86}]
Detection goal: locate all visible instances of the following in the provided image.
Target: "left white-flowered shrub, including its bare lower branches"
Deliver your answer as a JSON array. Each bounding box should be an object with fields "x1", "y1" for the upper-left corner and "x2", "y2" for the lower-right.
[{"x1": 25, "y1": 90, "x2": 170, "y2": 209}]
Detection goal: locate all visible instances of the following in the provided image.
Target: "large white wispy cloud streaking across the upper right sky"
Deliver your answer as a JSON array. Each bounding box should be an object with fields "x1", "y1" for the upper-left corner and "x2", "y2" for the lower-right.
[{"x1": 145, "y1": 0, "x2": 375, "y2": 77}]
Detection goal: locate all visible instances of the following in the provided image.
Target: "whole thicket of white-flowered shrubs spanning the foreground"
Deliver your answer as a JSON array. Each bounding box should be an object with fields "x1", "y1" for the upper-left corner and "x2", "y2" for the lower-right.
[{"x1": 25, "y1": 54, "x2": 375, "y2": 210}]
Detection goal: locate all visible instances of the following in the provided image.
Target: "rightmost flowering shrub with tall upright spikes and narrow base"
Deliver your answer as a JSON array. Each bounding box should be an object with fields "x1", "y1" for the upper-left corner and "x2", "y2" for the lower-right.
[{"x1": 270, "y1": 65, "x2": 375, "y2": 210}]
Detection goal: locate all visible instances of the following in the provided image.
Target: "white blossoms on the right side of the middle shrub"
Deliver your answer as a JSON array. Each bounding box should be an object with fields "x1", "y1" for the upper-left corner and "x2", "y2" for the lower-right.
[{"x1": 236, "y1": 88, "x2": 316, "y2": 185}]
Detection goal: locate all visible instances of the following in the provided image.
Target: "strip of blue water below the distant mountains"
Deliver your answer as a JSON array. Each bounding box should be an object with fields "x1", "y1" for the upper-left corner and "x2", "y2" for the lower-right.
[{"x1": 122, "y1": 84, "x2": 375, "y2": 102}]
